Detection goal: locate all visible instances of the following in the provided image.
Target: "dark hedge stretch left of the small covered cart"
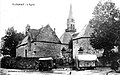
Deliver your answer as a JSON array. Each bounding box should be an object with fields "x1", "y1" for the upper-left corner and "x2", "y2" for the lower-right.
[{"x1": 1, "y1": 57, "x2": 39, "y2": 70}]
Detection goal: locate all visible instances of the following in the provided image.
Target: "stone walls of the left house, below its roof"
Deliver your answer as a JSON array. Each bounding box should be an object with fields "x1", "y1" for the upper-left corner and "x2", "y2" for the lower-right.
[{"x1": 16, "y1": 42, "x2": 61, "y2": 58}]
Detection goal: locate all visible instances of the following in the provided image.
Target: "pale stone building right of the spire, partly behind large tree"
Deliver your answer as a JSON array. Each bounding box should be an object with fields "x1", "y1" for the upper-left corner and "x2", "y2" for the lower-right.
[{"x1": 73, "y1": 25, "x2": 103, "y2": 59}]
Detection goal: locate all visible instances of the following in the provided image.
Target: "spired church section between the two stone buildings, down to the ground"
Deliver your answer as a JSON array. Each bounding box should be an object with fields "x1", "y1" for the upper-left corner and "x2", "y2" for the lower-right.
[{"x1": 60, "y1": 5, "x2": 76, "y2": 63}]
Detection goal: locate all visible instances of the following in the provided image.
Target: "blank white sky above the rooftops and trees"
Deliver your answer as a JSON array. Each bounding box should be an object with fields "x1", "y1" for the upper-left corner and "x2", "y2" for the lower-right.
[{"x1": 0, "y1": 0, "x2": 120, "y2": 41}]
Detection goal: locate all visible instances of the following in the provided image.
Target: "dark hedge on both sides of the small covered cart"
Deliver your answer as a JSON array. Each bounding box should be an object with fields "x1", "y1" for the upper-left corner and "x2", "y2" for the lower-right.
[{"x1": 1, "y1": 57, "x2": 70, "y2": 70}]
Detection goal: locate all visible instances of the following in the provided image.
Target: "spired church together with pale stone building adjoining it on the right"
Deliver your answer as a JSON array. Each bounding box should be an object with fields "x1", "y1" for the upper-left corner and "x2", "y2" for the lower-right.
[{"x1": 60, "y1": 5, "x2": 101, "y2": 58}]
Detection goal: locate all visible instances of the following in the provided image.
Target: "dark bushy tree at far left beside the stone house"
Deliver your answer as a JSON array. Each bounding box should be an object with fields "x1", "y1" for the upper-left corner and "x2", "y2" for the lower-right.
[{"x1": 1, "y1": 27, "x2": 24, "y2": 57}]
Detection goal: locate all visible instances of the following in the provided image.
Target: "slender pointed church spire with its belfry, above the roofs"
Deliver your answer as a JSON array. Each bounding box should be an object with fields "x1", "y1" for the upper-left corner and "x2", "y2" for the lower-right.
[{"x1": 65, "y1": 4, "x2": 76, "y2": 32}]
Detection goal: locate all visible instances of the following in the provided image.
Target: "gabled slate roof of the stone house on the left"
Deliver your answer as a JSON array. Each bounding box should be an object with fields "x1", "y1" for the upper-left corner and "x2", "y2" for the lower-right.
[{"x1": 20, "y1": 25, "x2": 60, "y2": 45}]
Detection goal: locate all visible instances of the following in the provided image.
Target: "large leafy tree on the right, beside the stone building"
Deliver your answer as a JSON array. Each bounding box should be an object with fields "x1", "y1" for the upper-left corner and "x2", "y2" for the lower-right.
[{"x1": 89, "y1": 1, "x2": 120, "y2": 61}]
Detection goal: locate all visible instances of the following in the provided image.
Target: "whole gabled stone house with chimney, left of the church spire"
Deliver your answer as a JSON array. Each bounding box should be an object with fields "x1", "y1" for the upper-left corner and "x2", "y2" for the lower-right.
[{"x1": 16, "y1": 25, "x2": 61, "y2": 58}]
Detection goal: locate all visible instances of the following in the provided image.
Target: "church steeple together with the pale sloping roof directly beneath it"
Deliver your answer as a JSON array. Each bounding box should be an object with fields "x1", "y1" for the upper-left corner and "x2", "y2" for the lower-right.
[{"x1": 60, "y1": 5, "x2": 76, "y2": 49}]
